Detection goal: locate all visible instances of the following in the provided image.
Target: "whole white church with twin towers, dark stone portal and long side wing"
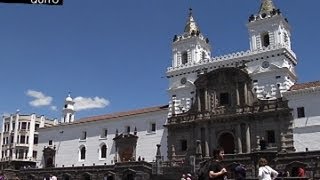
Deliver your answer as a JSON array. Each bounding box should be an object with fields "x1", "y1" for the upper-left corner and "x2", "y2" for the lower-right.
[{"x1": 2, "y1": 0, "x2": 320, "y2": 179}]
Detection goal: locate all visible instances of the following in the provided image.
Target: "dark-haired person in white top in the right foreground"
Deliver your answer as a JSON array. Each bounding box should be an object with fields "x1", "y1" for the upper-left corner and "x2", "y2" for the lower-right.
[{"x1": 258, "y1": 158, "x2": 279, "y2": 180}]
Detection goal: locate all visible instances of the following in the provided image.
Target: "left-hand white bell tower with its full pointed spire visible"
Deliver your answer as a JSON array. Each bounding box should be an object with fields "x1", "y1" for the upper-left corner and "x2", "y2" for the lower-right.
[{"x1": 167, "y1": 8, "x2": 211, "y2": 116}]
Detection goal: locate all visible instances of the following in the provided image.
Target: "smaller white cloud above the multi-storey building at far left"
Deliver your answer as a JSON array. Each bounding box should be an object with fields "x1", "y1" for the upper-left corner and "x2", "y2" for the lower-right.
[{"x1": 26, "y1": 89, "x2": 52, "y2": 107}]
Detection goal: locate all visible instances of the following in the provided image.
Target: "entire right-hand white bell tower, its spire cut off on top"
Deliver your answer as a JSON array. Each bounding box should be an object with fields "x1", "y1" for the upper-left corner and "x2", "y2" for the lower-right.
[{"x1": 246, "y1": 0, "x2": 297, "y2": 100}]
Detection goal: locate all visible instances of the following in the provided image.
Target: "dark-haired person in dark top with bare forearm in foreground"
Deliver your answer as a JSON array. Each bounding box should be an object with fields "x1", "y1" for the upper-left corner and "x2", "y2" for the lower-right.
[{"x1": 208, "y1": 148, "x2": 227, "y2": 180}]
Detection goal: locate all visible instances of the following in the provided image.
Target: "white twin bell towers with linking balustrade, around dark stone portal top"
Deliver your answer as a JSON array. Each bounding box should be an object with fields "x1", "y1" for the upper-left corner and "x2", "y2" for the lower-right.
[{"x1": 167, "y1": 1, "x2": 297, "y2": 115}]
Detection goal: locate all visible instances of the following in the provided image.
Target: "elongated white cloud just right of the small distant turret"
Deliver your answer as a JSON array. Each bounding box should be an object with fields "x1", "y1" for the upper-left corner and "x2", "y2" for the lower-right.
[{"x1": 73, "y1": 96, "x2": 110, "y2": 111}]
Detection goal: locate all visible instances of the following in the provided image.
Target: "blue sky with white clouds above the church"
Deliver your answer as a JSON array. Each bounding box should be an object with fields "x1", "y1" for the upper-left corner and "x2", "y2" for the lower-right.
[{"x1": 0, "y1": 0, "x2": 320, "y2": 119}]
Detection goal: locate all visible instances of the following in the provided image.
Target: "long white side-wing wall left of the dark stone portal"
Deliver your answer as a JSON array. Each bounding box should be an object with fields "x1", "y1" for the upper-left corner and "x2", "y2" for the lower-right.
[{"x1": 37, "y1": 110, "x2": 168, "y2": 167}]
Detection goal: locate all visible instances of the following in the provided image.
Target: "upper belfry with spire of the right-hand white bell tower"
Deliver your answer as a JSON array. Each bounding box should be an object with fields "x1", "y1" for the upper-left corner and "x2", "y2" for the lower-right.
[{"x1": 248, "y1": 0, "x2": 291, "y2": 51}]
